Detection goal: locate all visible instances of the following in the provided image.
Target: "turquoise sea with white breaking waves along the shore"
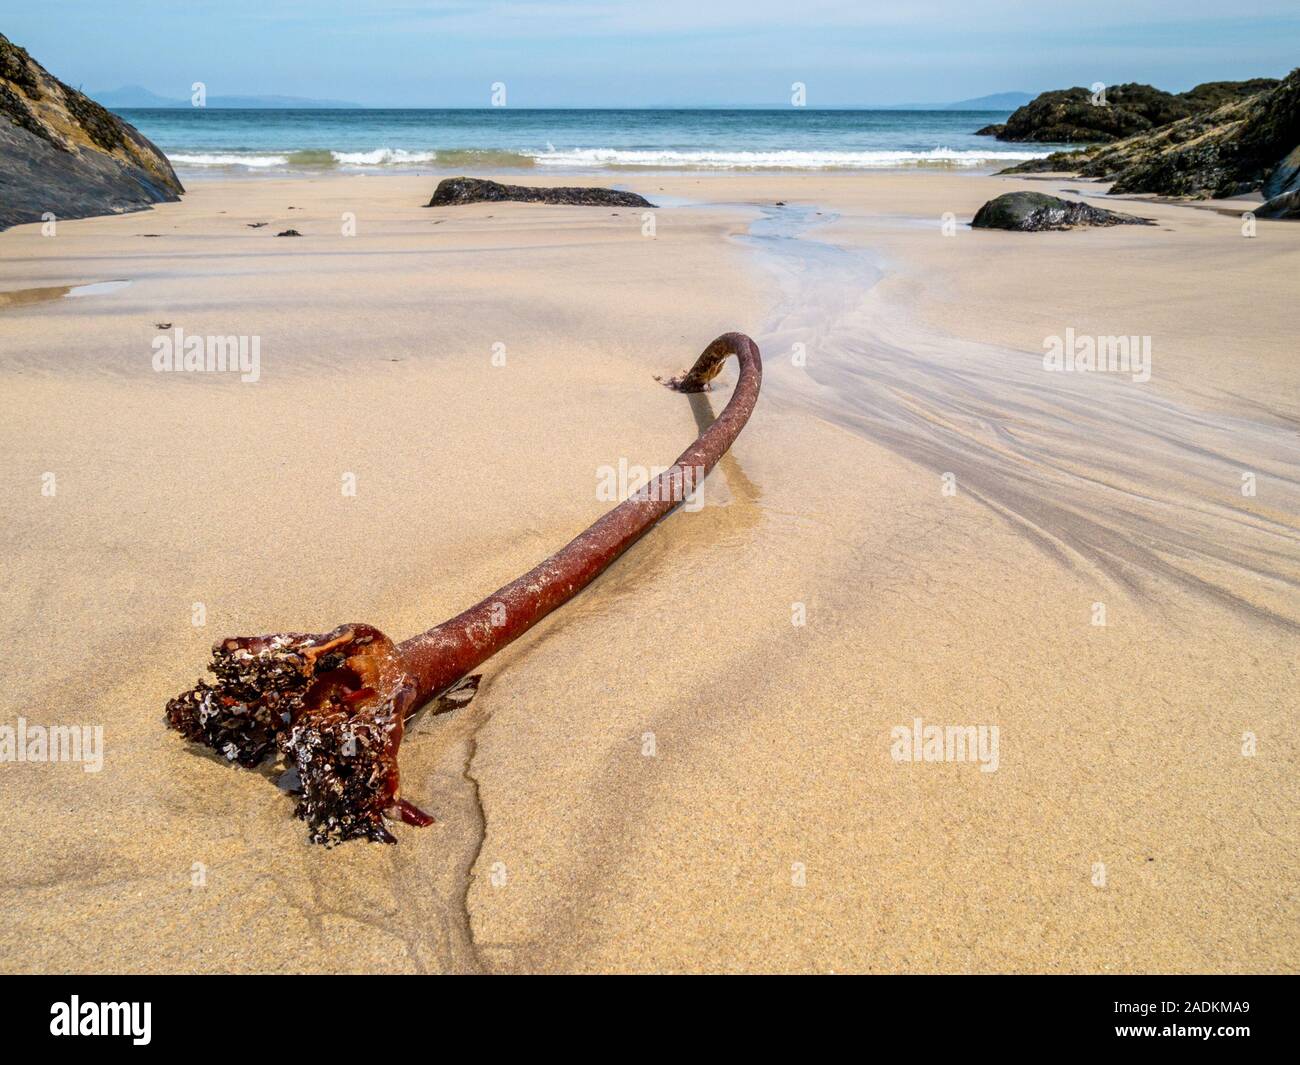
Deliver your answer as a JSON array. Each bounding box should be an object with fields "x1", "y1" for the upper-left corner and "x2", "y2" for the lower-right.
[{"x1": 121, "y1": 108, "x2": 1054, "y2": 173}]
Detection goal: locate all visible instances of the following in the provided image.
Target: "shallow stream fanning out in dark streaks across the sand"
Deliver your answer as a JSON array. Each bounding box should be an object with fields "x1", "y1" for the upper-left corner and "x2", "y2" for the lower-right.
[{"x1": 741, "y1": 205, "x2": 1300, "y2": 632}]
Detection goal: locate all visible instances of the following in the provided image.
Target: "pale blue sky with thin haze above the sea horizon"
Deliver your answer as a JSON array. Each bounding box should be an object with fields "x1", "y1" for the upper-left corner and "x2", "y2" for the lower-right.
[{"x1": 10, "y1": 0, "x2": 1300, "y2": 107}]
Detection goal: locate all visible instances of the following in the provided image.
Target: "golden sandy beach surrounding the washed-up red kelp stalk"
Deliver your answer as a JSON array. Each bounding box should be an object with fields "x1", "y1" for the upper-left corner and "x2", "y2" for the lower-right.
[{"x1": 0, "y1": 170, "x2": 1300, "y2": 973}]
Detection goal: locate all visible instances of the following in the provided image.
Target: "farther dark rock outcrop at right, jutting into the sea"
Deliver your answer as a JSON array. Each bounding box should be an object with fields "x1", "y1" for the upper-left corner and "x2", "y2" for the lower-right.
[{"x1": 980, "y1": 78, "x2": 1278, "y2": 144}]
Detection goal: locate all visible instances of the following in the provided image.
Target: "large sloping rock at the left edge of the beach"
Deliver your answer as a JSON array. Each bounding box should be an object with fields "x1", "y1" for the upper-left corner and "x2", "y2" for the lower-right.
[{"x1": 0, "y1": 35, "x2": 185, "y2": 229}]
